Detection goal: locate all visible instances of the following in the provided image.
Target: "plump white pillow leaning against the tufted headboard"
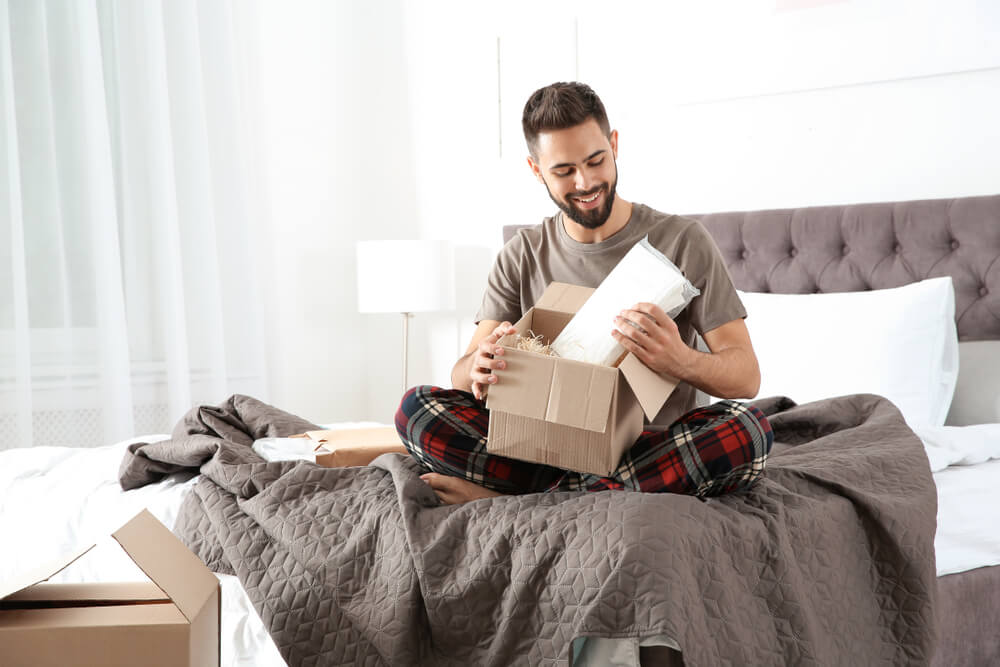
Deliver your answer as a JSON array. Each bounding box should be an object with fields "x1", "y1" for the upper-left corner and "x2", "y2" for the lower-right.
[{"x1": 739, "y1": 277, "x2": 958, "y2": 426}]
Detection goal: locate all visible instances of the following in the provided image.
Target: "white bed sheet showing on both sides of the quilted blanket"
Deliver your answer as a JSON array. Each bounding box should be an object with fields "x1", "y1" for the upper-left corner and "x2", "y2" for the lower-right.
[{"x1": 0, "y1": 422, "x2": 1000, "y2": 667}]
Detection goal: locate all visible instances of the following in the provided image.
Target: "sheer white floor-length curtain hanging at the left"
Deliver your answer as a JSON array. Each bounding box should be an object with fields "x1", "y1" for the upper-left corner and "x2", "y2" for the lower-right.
[{"x1": 0, "y1": 0, "x2": 267, "y2": 449}]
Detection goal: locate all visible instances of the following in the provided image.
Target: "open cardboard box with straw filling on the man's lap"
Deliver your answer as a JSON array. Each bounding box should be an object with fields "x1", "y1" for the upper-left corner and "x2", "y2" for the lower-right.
[{"x1": 486, "y1": 282, "x2": 677, "y2": 475}]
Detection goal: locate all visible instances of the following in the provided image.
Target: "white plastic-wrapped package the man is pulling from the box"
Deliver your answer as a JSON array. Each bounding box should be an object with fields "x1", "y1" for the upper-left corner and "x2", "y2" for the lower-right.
[{"x1": 552, "y1": 237, "x2": 701, "y2": 366}]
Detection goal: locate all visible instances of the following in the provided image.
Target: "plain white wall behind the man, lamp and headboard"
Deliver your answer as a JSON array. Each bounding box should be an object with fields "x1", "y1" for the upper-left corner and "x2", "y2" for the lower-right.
[{"x1": 262, "y1": 0, "x2": 1000, "y2": 421}]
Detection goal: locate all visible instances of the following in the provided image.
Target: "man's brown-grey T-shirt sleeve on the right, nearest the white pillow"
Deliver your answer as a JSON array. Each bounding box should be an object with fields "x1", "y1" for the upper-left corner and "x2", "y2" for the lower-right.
[{"x1": 678, "y1": 221, "x2": 747, "y2": 336}]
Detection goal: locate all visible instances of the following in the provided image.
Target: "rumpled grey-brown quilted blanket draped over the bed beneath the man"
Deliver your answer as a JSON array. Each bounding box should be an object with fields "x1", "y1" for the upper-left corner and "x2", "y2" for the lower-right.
[{"x1": 120, "y1": 395, "x2": 937, "y2": 667}]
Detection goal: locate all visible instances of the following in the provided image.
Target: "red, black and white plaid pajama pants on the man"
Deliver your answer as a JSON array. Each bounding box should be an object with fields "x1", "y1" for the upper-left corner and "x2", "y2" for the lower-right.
[{"x1": 396, "y1": 385, "x2": 774, "y2": 497}]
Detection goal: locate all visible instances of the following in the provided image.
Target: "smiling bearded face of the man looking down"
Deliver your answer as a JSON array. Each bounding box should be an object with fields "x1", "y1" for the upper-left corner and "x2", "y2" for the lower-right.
[{"x1": 528, "y1": 119, "x2": 618, "y2": 229}]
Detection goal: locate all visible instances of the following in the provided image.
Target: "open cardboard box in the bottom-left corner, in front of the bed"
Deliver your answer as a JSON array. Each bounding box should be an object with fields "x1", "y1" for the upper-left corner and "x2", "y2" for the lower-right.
[{"x1": 0, "y1": 510, "x2": 220, "y2": 667}]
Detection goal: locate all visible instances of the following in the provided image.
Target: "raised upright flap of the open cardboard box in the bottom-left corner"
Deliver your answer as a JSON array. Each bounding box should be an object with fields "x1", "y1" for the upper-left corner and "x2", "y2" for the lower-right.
[{"x1": 112, "y1": 510, "x2": 219, "y2": 622}]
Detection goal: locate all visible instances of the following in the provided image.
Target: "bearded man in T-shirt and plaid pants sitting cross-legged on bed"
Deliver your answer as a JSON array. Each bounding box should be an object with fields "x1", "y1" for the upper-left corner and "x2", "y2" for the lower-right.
[{"x1": 396, "y1": 83, "x2": 772, "y2": 503}]
